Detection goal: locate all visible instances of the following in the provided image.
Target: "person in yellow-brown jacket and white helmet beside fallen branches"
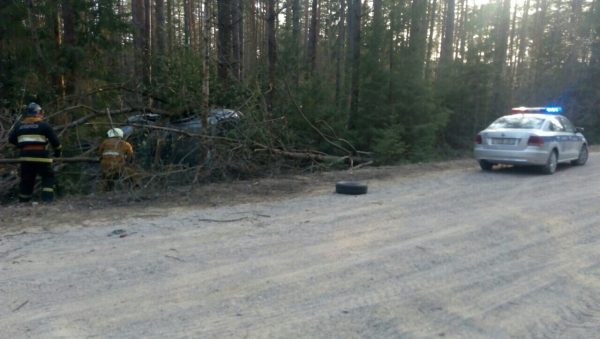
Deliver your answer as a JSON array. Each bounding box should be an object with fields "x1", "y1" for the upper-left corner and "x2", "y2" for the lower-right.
[{"x1": 98, "y1": 128, "x2": 134, "y2": 191}]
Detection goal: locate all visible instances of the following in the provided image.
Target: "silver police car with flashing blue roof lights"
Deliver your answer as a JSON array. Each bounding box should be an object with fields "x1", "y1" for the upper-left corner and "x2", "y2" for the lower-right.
[{"x1": 474, "y1": 107, "x2": 588, "y2": 174}]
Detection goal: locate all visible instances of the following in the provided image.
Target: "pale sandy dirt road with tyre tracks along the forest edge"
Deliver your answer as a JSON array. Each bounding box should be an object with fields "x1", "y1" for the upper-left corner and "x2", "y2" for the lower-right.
[{"x1": 0, "y1": 153, "x2": 600, "y2": 338}]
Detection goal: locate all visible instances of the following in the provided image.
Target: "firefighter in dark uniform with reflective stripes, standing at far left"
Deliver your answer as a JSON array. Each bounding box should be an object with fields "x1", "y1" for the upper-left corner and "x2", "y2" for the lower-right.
[{"x1": 8, "y1": 102, "x2": 62, "y2": 202}]
